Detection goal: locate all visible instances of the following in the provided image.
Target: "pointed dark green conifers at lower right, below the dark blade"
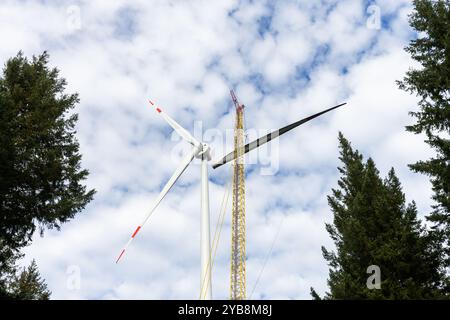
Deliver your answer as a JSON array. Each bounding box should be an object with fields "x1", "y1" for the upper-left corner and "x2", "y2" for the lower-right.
[{"x1": 322, "y1": 133, "x2": 442, "y2": 299}]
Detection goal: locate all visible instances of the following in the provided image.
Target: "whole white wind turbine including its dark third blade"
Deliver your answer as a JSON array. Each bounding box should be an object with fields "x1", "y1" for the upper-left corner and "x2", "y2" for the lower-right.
[{"x1": 116, "y1": 100, "x2": 345, "y2": 300}]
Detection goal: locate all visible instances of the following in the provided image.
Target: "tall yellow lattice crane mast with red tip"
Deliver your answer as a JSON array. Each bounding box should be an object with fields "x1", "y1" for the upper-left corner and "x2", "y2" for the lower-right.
[{"x1": 230, "y1": 90, "x2": 246, "y2": 300}]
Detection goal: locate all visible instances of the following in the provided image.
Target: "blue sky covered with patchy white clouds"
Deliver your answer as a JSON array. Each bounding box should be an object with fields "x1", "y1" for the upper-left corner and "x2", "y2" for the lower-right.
[{"x1": 0, "y1": 0, "x2": 436, "y2": 299}]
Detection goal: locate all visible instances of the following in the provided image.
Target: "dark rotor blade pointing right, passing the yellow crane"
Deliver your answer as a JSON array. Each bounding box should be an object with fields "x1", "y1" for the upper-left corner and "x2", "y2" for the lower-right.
[{"x1": 212, "y1": 103, "x2": 347, "y2": 169}]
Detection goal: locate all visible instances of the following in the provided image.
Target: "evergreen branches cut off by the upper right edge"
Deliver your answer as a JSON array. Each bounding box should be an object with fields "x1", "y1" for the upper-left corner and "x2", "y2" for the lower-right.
[{"x1": 398, "y1": 0, "x2": 450, "y2": 276}]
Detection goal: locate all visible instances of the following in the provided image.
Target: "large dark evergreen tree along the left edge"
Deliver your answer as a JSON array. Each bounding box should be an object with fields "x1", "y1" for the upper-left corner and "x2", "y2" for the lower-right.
[{"x1": 0, "y1": 52, "x2": 95, "y2": 294}]
